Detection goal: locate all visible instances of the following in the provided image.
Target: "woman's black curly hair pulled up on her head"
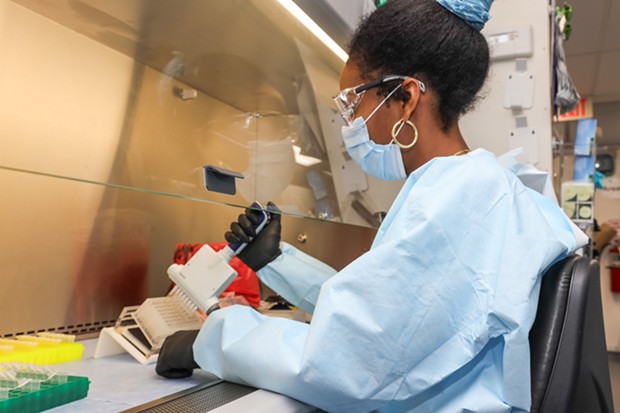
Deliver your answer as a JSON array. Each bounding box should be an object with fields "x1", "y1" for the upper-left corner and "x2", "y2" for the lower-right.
[{"x1": 349, "y1": 0, "x2": 489, "y2": 131}]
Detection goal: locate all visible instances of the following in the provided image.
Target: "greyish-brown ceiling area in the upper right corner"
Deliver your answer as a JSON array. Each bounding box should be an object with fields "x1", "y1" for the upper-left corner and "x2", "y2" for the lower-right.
[{"x1": 558, "y1": 0, "x2": 620, "y2": 103}]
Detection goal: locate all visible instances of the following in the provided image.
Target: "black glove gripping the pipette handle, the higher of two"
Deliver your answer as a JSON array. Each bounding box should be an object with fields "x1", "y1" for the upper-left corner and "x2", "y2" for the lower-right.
[{"x1": 224, "y1": 202, "x2": 282, "y2": 272}]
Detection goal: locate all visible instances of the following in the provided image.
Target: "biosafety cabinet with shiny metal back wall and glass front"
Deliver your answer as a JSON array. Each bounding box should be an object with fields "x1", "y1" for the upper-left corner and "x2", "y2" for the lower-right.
[{"x1": 0, "y1": 0, "x2": 388, "y2": 336}]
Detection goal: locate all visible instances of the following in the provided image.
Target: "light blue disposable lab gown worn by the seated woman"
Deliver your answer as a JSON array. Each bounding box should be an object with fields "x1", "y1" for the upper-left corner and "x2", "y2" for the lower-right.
[{"x1": 194, "y1": 149, "x2": 575, "y2": 413}]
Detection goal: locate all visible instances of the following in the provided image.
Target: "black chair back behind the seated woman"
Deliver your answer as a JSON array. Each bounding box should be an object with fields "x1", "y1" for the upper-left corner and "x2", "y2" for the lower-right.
[{"x1": 530, "y1": 255, "x2": 614, "y2": 413}]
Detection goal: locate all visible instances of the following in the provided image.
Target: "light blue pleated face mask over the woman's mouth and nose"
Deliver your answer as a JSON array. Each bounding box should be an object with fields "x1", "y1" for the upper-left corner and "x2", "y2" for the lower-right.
[{"x1": 342, "y1": 117, "x2": 407, "y2": 181}]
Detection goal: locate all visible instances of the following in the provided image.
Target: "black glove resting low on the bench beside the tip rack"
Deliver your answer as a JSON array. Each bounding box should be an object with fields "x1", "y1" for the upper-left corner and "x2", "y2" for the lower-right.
[{"x1": 155, "y1": 330, "x2": 200, "y2": 379}]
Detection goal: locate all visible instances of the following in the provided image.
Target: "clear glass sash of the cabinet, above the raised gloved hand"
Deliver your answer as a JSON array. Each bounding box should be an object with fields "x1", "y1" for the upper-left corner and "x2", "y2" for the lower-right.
[{"x1": 0, "y1": 0, "x2": 397, "y2": 226}]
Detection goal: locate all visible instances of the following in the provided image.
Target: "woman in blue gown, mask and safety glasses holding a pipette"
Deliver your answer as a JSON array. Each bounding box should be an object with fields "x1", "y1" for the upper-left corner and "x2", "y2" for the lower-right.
[{"x1": 158, "y1": 0, "x2": 576, "y2": 413}]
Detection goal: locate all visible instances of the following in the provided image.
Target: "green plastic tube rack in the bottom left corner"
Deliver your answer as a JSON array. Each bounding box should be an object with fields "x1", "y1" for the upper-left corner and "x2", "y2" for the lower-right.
[{"x1": 0, "y1": 376, "x2": 90, "y2": 413}]
